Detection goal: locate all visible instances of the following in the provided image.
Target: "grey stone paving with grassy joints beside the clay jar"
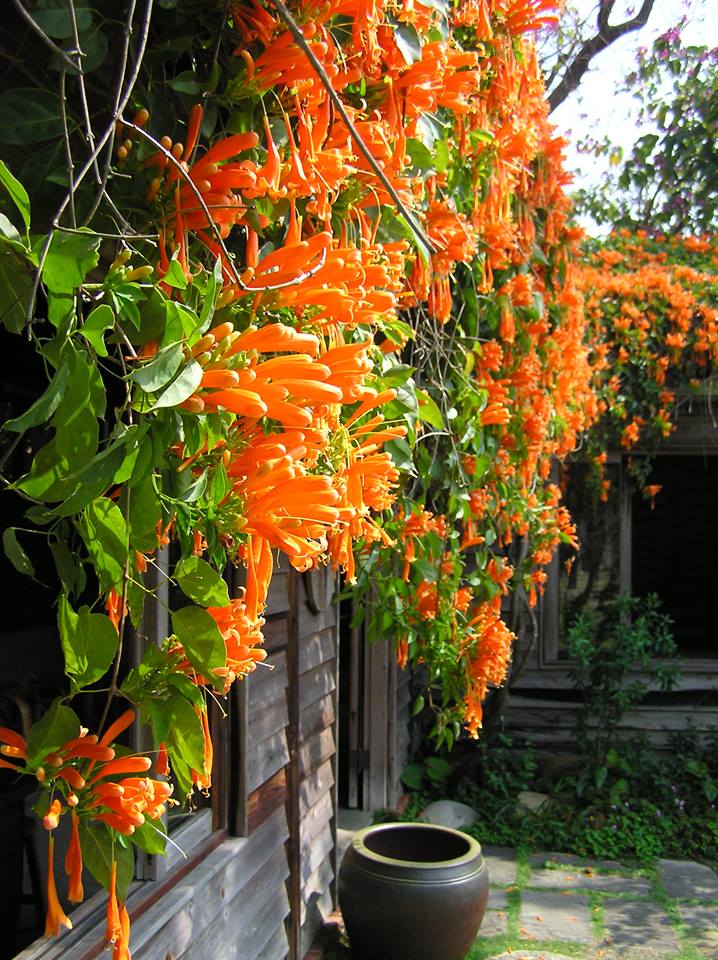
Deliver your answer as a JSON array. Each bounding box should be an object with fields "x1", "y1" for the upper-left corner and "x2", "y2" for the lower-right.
[{"x1": 317, "y1": 847, "x2": 718, "y2": 960}]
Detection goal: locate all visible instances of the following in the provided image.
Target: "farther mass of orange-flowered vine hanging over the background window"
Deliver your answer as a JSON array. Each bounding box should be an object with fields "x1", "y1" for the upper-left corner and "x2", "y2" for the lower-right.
[{"x1": 578, "y1": 231, "x2": 718, "y2": 462}]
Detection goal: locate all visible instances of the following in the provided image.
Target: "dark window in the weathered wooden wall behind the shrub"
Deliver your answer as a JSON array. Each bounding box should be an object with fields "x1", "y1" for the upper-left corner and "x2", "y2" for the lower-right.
[{"x1": 543, "y1": 444, "x2": 718, "y2": 663}]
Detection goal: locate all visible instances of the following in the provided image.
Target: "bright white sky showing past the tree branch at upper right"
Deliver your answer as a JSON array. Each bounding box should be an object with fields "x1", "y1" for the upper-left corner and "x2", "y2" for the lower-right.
[{"x1": 551, "y1": 0, "x2": 718, "y2": 223}]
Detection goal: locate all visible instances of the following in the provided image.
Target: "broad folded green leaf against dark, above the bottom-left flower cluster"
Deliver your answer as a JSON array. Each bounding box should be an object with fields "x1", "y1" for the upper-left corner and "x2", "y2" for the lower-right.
[{"x1": 57, "y1": 594, "x2": 119, "y2": 687}]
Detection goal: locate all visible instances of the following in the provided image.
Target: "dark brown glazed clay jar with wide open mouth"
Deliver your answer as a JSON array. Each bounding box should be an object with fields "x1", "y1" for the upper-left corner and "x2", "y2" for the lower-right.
[{"x1": 338, "y1": 823, "x2": 489, "y2": 960}]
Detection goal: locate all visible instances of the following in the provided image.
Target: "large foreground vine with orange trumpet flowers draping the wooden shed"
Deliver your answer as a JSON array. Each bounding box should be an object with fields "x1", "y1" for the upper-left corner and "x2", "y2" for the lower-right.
[{"x1": 0, "y1": 0, "x2": 715, "y2": 958}]
